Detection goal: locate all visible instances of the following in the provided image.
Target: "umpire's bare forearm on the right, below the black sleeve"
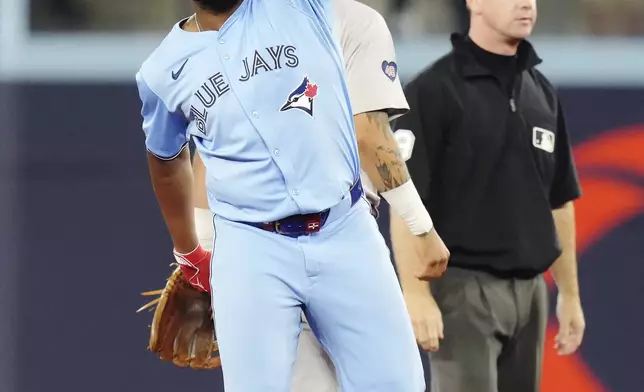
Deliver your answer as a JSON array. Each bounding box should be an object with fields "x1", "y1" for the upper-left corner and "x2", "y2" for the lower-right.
[{"x1": 550, "y1": 202, "x2": 579, "y2": 297}]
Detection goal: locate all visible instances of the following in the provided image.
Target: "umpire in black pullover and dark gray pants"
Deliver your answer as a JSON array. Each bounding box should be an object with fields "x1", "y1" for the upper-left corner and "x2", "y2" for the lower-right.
[{"x1": 391, "y1": 0, "x2": 585, "y2": 392}]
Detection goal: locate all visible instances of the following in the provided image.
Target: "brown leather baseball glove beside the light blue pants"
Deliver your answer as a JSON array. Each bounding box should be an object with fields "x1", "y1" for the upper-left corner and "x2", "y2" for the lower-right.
[{"x1": 137, "y1": 266, "x2": 221, "y2": 369}]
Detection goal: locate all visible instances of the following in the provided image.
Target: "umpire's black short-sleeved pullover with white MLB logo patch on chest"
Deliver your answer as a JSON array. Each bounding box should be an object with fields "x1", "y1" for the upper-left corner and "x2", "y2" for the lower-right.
[{"x1": 394, "y1": 34, "x2": 581, "y2": 278}]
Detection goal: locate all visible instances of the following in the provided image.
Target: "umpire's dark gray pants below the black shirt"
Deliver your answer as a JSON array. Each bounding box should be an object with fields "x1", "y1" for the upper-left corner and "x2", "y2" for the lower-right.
[{"x1": 429, "y1": 267, "x2": 548, "y2": 392}]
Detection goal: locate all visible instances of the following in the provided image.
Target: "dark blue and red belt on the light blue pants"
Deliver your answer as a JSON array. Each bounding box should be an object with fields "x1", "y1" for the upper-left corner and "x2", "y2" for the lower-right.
[{"x1": 248, "y1": 179, "x2": 364, "y2": 237}]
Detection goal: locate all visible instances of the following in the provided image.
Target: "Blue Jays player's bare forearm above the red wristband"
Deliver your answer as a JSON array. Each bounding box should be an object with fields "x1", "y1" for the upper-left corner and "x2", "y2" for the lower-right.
[{"x1": 148, "y1": 149, "x2": 198, "y2": 253}]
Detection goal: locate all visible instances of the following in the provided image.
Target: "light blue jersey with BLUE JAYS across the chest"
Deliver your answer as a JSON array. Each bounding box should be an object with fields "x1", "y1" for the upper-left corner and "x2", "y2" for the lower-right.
[{"x1": 136, "y1": 0, "x2": 360, "y2": 222}]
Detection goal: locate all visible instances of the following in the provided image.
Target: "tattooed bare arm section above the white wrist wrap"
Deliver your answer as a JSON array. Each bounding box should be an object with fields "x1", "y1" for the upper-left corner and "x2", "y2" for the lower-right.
[{"x1": 356, "y1": 112, "x2": 409, "y2": 192}]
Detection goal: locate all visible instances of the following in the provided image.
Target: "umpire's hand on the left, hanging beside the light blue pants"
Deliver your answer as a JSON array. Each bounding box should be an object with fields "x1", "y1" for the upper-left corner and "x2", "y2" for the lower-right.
[{"x1": 405, "y1": 292, "x2": 443, "y2": 351}]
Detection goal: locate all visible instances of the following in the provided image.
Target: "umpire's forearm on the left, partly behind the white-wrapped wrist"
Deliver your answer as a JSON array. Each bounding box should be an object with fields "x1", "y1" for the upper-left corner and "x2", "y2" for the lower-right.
[{"x1": 389, "y1": 213, "x2": 431, "y2": 296}]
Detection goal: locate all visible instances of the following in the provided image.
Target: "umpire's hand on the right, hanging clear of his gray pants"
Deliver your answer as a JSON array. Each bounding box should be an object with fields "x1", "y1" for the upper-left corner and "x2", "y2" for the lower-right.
[{"x1": 555, "y1": 293, "x2": 586, "y2": 355}]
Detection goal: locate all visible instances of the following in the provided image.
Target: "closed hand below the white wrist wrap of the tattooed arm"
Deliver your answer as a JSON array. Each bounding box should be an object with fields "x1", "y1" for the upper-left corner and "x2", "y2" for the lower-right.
[{"x1": 415, "y1": 229, "x2": 449, "y2": 280}]
